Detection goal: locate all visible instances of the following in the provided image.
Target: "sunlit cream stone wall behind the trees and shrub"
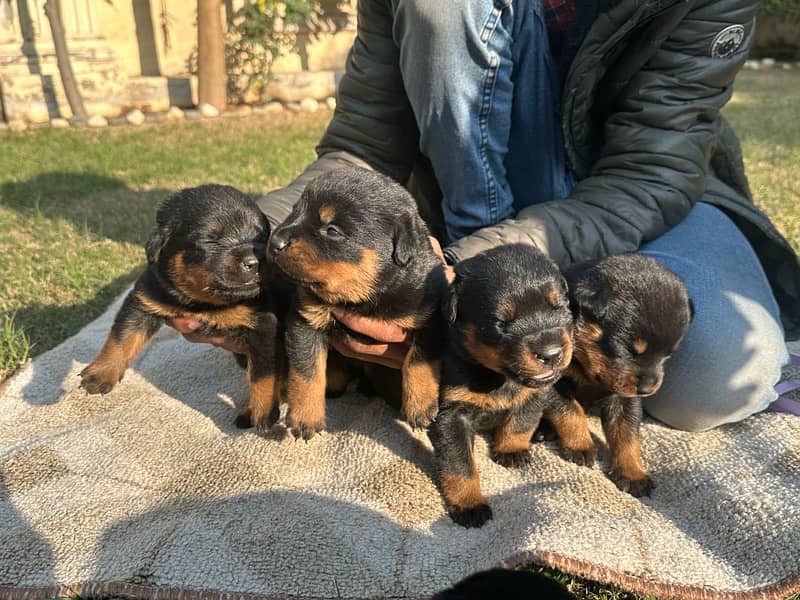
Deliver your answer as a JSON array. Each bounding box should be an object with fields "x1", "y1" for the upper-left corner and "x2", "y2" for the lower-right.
[{"x1": 0, "y1": 0, "x2": 355, "y2": 123}]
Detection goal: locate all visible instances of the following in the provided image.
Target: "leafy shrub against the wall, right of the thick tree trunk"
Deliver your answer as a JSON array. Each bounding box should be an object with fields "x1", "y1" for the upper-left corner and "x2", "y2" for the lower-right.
[{"x1": 225, "y1": 0, "x2": 348, "y2": 103}]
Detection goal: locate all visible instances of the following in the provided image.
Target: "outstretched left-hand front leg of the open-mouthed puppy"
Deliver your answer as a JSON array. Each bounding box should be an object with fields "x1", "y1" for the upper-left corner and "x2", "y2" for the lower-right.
[{"x1": 430, "y1": 404, "x2": 492, "y2": 527}]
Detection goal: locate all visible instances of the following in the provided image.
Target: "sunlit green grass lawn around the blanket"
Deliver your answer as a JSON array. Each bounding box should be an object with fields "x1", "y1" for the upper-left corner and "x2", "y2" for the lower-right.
[{"x1": 0, "y1": 70, "x2": 800, "y2": 600}]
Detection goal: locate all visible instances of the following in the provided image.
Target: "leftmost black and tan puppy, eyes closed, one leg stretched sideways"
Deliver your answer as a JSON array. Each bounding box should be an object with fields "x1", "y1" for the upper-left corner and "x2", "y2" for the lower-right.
[{"x1": 80, "y1": 185, "x2": 278, "y2": 427}]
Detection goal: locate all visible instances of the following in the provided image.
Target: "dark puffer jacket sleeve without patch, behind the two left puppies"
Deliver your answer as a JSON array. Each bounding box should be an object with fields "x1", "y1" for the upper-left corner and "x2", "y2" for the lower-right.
[{"x1": 259, "y1": 0, "x2": 419, "y2": 225}]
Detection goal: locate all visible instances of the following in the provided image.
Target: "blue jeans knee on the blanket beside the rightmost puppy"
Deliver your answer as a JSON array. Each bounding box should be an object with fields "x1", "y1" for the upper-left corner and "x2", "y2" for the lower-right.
[{"x1": 640, "y1": 202, "x2": 789, "y2": 431}]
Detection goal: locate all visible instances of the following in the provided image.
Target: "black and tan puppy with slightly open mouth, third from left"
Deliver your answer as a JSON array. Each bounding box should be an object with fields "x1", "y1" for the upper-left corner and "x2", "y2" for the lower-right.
[{"x1": 430, "y1": 244, "x2": 572, "y2": 527}]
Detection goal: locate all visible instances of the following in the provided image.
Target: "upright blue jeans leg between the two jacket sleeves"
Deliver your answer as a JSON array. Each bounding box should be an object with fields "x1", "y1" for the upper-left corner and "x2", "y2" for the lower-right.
[{"x1": 392, "y1": 0, "x2": 571, "y2": 240}]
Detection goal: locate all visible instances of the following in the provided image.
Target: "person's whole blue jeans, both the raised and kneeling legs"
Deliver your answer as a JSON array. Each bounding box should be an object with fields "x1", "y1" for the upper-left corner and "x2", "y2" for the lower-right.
[{"x1": 392, "y1": 0, "x2": 788, "y2": 430}]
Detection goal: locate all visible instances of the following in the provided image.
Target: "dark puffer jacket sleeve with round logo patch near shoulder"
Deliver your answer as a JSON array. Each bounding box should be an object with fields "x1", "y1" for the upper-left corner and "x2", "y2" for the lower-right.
[{"x1": 445, "y1": 0, "x2": 758, "y2": 267}]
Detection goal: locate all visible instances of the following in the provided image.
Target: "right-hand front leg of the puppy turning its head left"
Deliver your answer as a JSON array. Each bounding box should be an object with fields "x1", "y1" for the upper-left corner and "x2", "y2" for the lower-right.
[{"x1": 402, "y1": 323, "x2": 442, "y2": 427}]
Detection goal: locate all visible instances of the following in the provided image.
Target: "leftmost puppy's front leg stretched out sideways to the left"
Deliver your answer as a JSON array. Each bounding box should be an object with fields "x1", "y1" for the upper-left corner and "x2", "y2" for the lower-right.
[{"x1": 80, "y1": 289, "x2": 163, "y2": 394}]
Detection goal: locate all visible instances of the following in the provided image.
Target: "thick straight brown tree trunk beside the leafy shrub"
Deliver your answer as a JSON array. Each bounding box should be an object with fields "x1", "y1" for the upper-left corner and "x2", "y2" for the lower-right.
[{"x1": 197, "y1": 0, "x2": 226, "y2": 111}]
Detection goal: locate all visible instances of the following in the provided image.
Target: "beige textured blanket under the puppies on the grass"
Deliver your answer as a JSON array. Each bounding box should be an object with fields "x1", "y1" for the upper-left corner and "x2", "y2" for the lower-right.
[{"x1": 0, "y1": 292, "x2": 800, "y2": 599}]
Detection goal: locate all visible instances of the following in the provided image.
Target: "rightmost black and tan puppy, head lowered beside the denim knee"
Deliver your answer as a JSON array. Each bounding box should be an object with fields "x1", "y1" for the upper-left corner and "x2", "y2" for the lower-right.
[{"x1": 556, "y1": 254, "x2": 693, "y2": 497}]
